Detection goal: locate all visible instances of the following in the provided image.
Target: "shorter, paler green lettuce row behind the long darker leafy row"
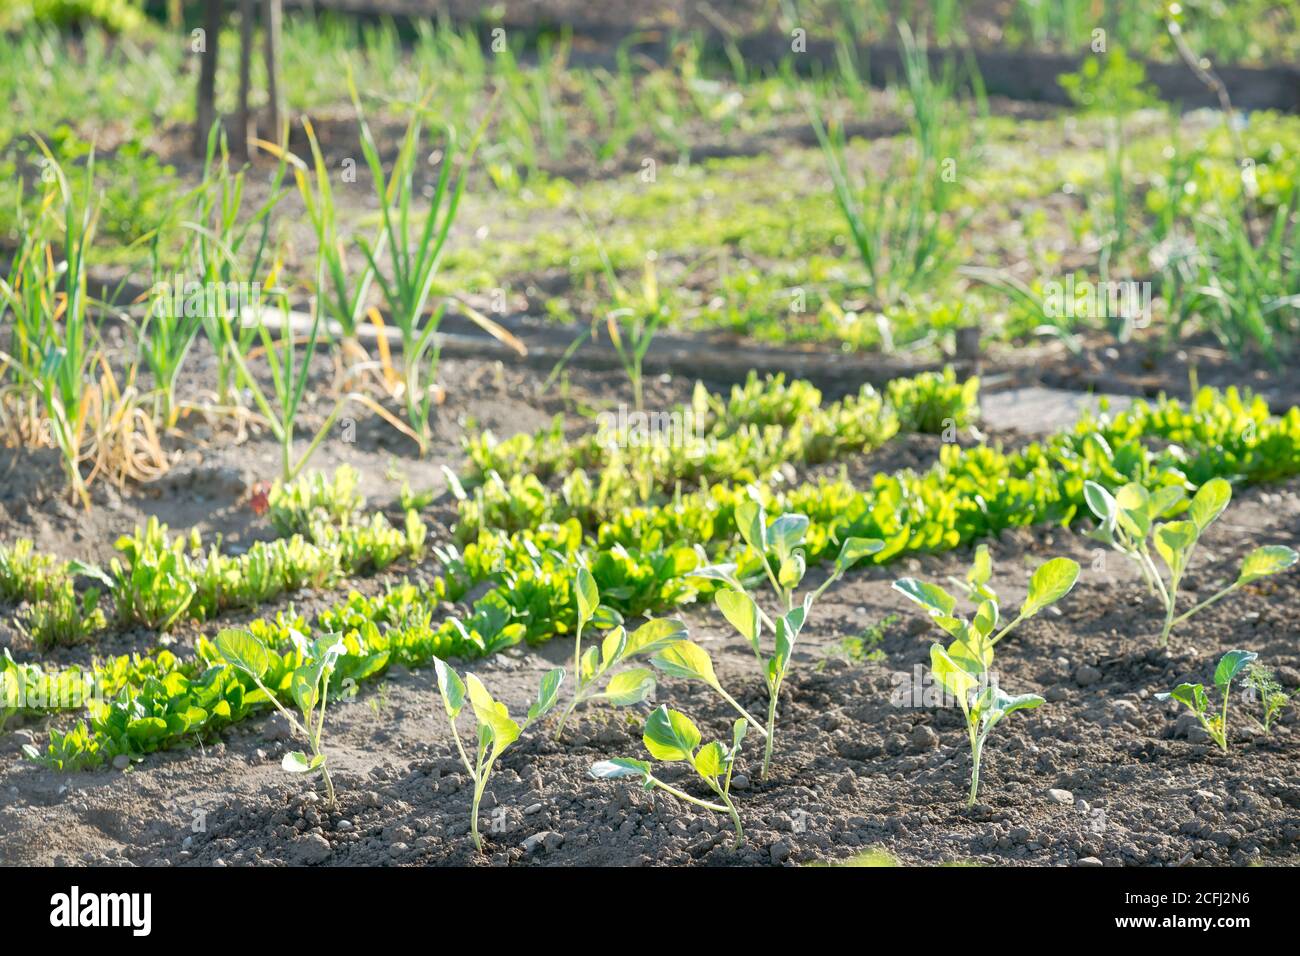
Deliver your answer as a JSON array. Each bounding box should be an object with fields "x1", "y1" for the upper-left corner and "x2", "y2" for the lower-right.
[{"x1": 0, "y1": 369, "x2": 979, "y2": 649}]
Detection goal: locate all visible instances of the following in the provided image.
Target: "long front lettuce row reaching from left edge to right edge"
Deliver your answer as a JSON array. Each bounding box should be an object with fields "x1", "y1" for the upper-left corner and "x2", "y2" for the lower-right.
[{"x1": 0, "y1": 377, "x2": 1300, "y2": 769}]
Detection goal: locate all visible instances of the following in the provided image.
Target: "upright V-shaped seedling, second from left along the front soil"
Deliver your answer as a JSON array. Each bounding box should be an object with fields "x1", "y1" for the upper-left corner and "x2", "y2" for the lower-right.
[{"x1": 433, "y1": 657, "x2": 564, "y2": 852}]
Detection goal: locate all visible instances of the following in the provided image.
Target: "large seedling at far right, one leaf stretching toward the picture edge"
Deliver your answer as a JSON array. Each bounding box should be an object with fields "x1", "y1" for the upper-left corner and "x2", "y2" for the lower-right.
[{"x1": 1083, "y1": 479, "x2": 1297, "y2": 646}]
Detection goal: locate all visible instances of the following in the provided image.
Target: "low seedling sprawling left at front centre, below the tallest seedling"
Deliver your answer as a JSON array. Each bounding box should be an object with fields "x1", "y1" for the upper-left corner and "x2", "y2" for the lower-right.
[{"x1": 589, "y1": 705, "x2": 748, "y2": 849}]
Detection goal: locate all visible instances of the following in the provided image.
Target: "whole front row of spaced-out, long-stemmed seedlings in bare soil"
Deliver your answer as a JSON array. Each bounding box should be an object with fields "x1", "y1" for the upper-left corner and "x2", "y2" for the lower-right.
[{"x1": 157, "y1": 479, "x2": 1297, "y2": 849}]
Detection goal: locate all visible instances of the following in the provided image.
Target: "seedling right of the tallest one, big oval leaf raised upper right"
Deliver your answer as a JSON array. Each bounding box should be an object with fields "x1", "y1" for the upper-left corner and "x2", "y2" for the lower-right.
[{"x1": 893, "y1": 549, "x2": 1079, "y2": 806}]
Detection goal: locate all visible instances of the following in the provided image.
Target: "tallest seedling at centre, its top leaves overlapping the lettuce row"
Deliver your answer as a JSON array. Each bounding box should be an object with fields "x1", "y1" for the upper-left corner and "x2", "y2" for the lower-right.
[{"x1": 696, "y1": 498, "x2": 885, "y2": 780}]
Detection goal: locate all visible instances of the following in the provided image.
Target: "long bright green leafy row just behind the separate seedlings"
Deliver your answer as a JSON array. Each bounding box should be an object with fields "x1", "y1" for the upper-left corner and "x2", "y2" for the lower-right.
[{"x1": 20, "y1": 392, "x2": 1300, "y2": 766}]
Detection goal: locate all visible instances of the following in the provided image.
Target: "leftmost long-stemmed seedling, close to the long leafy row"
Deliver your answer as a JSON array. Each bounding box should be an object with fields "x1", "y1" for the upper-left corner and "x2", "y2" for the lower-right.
[{"x1": 215, "y1": 628, "x2": 343, "y2": 806}]
